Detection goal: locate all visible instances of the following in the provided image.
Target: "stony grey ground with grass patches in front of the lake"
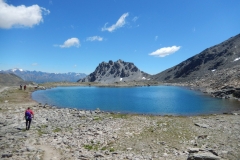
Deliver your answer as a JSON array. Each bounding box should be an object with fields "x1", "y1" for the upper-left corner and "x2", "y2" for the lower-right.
[{"x1": 0, "y1": 87, "x2": 240, "y2": 160}]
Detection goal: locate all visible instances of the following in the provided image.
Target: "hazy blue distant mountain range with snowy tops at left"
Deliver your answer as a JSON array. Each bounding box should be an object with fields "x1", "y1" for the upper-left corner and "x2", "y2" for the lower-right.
[{"x1": 0, "y1": 68, "x2": 87, "y2": 83}]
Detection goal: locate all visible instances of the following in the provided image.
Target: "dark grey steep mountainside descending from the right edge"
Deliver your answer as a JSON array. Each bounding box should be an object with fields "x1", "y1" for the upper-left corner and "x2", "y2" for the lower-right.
[{"x1": 152, "y1": 34, "x2": 240, "y2": 85}]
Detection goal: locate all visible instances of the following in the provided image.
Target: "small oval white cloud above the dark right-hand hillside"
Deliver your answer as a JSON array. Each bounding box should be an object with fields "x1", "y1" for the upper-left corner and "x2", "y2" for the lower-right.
[{"x1": 149, "y1": 46, "x2": 181, "y2": 57}]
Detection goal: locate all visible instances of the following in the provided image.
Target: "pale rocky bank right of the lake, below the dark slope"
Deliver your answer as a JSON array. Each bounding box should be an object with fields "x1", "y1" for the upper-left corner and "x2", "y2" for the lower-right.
[{"x1": 164, "y1": 65, "x2": 240, "y2": 101}]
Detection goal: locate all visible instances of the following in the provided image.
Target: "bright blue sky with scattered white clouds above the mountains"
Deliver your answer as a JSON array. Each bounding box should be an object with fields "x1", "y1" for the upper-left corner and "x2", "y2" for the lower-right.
[{"x1": 0, "y1": 0, "x2": 240, "y2": 74}]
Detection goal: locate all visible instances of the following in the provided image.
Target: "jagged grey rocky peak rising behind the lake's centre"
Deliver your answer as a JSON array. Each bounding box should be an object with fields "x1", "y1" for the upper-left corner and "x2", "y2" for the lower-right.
[{"x1": 79, "y1": 60, "x2": 150, "y2": 83}]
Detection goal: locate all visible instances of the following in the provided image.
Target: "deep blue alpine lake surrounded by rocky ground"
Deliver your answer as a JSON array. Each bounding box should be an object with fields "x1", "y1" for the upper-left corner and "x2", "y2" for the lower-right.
[{"x1": 32, "y1": 86, "x2": 240, "y2": 115}]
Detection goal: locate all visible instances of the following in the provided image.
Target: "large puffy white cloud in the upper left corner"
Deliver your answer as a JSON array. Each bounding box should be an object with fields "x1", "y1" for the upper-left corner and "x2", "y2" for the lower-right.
[{"x1": 0, "y1": 0, "x2": 50, "y2": 29}]
